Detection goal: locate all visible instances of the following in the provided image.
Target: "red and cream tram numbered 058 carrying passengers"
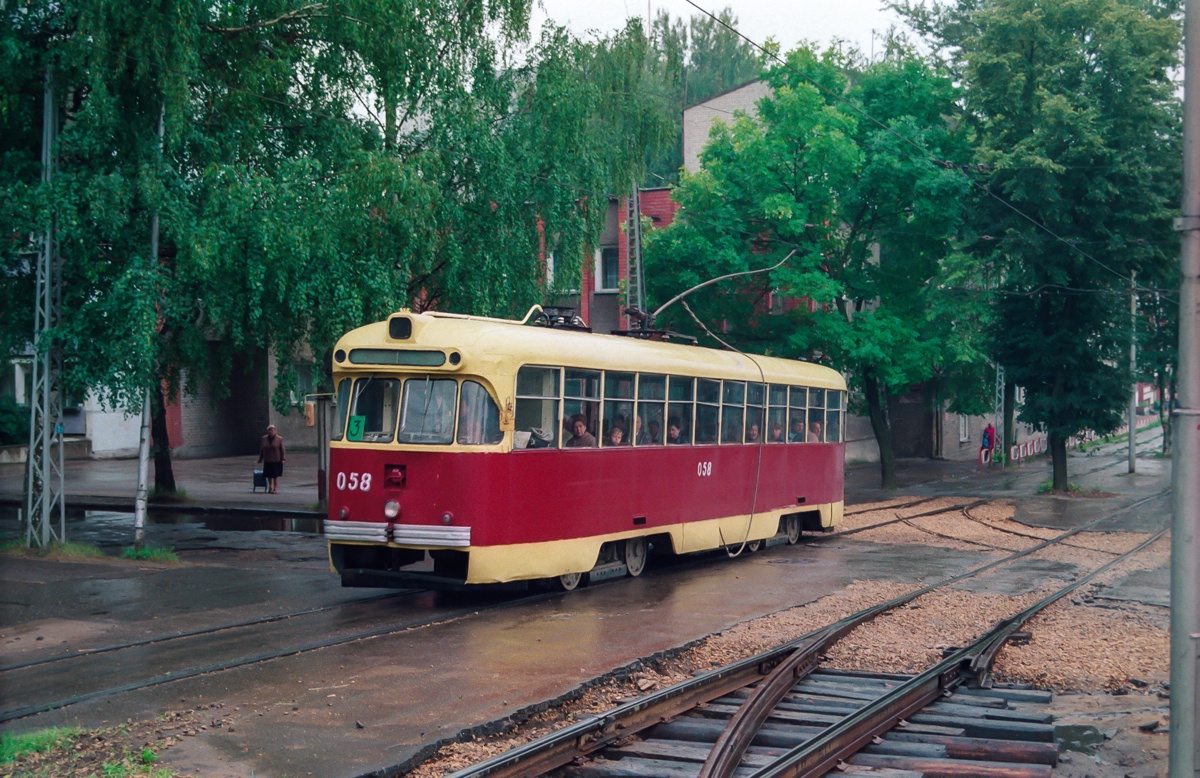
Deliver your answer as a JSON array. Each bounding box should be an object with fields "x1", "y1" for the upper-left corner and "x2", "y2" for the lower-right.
[{"x1": 325, "y1": 311, "x2": 846, "y2": 588}]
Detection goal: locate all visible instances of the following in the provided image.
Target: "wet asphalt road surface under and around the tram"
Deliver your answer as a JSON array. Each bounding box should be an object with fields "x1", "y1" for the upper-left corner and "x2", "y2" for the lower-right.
[{"x1": 0, "y1": 425, "x2": 1170, "y2": 776}]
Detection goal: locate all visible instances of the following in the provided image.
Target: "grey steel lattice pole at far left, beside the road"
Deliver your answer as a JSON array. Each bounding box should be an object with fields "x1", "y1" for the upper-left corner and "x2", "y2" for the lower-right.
[{"x1": 25, "y1": 66, "x2": 67, "y2": 549}]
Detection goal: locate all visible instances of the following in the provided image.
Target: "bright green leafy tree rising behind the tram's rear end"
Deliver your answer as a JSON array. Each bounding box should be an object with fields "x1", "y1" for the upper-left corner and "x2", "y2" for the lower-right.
[{"x1": 647, "y1": 48, "x2": 984, "y2": 487}]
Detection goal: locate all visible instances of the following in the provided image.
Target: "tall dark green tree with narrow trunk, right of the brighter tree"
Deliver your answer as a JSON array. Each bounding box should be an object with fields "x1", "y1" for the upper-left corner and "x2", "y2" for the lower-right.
[{"x1": 911, "y1": 0, "x2": 1180, "y2": 490}]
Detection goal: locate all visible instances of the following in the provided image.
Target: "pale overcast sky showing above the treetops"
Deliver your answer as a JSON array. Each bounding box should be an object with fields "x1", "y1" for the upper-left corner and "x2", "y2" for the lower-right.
[{"x1": 532, "y1": 0, "x2": 895, "y2": 54}]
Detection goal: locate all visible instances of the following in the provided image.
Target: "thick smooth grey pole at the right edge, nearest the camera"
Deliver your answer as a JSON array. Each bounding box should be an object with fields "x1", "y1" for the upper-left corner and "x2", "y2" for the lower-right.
[{"x1": 1170, "y1": 0, "x2": 1200, "y2": 778}]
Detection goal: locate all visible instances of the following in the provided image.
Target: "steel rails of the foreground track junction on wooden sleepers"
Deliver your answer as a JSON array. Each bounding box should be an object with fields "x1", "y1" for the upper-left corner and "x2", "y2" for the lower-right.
[{"x1": 436, "y1": 493, "x2": 1166, "y2": 778}]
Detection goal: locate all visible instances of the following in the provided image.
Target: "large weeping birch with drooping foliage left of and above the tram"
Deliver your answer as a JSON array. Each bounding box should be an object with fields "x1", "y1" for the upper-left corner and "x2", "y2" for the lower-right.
[{"x1": 0, "y1": 0, "x2": 662, "y2": 491}]
